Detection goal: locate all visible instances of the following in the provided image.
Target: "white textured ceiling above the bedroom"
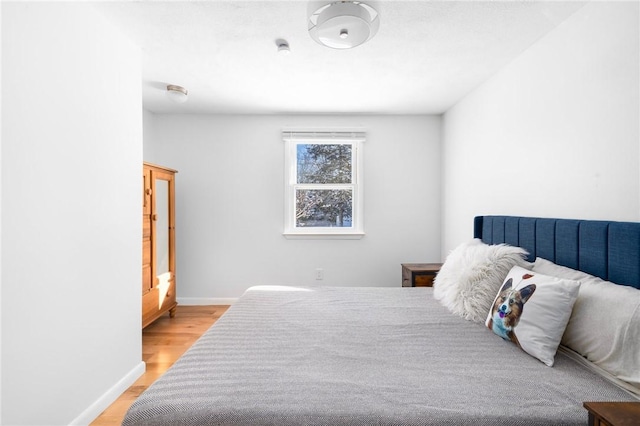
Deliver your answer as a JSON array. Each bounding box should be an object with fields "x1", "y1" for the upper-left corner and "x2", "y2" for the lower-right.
[{"x1": 95, "y1": 0, "x2": 585, "y2": 114}]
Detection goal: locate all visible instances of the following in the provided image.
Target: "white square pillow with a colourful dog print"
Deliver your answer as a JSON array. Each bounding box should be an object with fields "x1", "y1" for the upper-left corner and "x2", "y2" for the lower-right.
[{"x1": 485, "y1": 266, "x2": 580, "y2": 367}]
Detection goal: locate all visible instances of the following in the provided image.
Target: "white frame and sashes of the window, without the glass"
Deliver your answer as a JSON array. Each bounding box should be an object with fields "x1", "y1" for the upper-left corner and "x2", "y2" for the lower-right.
[{"x1": 282, "y1": 130, "x2": 365, "y2": 239}]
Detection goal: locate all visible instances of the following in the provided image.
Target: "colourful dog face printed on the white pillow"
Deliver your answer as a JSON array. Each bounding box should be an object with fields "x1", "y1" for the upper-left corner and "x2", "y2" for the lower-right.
[{"x1": 487, "y1": 274, "x2": 536, "y2": 346}]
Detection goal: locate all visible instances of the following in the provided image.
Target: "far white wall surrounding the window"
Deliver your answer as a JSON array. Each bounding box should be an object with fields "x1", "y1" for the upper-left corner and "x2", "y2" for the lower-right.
[{"x1": 144, "y1": 115, "x2": 440, "y2": 303}]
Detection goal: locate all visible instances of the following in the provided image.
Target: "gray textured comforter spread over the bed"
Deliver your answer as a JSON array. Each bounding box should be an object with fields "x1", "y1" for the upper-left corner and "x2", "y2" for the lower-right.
[{"x1": 123, "y1": 287, "x2": 634, "y2": 425}]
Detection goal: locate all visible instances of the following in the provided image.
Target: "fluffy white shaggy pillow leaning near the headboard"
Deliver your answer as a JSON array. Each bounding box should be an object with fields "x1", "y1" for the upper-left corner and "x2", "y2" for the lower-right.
[{"x1": 433, "y1": 239, "x2": 529, "y2": 323}]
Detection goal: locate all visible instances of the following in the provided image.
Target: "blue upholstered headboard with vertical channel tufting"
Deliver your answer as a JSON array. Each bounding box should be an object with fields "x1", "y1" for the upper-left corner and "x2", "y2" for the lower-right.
[{"x1": 474, "y1": 216, "x2": 640, "y2": 289}]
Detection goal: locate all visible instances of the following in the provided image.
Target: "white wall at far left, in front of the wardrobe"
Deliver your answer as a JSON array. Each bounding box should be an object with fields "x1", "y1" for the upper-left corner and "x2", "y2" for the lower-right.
[{"x1": 1, "y1": 2, "x2": 144, "y2": 425}]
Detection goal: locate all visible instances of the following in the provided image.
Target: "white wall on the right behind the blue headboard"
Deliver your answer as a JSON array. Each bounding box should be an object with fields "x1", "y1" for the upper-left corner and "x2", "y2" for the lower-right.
[{"x1": 442, "y1": 2, "x2": 640, "y2": 255}]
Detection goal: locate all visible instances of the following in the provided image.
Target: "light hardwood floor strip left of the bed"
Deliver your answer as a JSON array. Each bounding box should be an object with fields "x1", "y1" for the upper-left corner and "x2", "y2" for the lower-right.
[{"x1": 91, "y1": 306, "x2": 228, "y2": 426}]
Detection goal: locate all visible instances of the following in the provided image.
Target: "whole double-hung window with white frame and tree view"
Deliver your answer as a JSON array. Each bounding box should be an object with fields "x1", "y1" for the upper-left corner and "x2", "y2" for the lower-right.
[{"x1": 283, "y1": 132, "x2": 364, "y2": 238}]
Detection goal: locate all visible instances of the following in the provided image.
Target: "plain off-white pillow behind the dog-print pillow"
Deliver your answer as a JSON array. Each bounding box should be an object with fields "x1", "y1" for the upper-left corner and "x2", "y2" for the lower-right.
[{"x1": 533, "y1": 258, "x2": 640, "y2": 387}]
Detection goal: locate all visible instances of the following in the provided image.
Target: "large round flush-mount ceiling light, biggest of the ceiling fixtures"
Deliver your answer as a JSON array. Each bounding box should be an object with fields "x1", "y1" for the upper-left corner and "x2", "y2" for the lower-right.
[{"x1": 309, "y1": 1, "x2": 380, "y2": 49}]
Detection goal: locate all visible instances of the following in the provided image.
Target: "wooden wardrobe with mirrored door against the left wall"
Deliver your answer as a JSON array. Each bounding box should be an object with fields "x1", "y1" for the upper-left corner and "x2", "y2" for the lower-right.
[{"x1": 142, "y1": 163, "x2": 177, "y2": 328}]
